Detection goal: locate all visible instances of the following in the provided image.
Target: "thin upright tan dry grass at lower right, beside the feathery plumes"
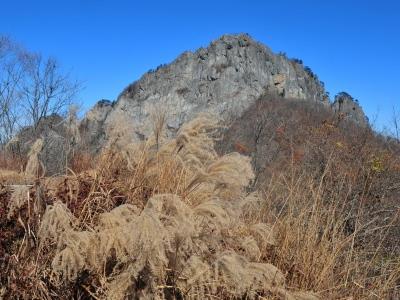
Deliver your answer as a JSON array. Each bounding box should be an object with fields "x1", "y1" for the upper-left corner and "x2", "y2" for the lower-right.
[{"x1": 264, "y1": 167, "x2": 400, "y2": 299}]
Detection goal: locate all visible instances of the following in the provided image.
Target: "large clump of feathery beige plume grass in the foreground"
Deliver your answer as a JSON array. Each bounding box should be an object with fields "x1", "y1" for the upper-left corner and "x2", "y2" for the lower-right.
[{"x1": 0, "y1": 115, "x2": 313, "y2": 299}]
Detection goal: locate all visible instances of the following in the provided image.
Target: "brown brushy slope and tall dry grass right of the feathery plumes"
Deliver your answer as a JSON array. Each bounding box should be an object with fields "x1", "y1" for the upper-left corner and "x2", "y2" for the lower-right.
[{"x1": 220, "y1": 96, "x2": 400, "y2": 299}]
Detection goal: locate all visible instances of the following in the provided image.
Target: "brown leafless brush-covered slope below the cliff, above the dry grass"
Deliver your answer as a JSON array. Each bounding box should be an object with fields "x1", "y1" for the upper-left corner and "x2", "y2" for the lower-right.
[{"x1": 218, "y1": 94, "x2": 400, "y2": 264}]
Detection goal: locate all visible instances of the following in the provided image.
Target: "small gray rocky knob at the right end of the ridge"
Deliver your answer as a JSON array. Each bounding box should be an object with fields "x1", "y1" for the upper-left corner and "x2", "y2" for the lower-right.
[{"x1": 332, "y1": 92, "x2": 369, "y2": 127}]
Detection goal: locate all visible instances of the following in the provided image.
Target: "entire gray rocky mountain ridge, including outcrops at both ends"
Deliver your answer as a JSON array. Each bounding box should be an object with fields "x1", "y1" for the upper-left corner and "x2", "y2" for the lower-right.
[{"x1": 9, "y1": 34, "x2": 368, "y2": 174}]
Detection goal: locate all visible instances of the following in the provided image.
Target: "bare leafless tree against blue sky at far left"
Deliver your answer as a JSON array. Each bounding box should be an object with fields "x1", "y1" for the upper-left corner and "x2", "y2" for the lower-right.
[{"x1": 0, "y1": 36, "x2": 81, "y2": 145}]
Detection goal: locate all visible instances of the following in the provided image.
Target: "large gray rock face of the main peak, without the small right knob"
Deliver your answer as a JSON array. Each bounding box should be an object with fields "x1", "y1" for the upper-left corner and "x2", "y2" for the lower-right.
[{"x1": 81, "y1": 34, "x2": 329, "y2": 149}]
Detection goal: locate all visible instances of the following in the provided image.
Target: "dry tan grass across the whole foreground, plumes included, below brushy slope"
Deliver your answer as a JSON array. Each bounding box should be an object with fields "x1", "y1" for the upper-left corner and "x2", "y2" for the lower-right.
[{"x1": 0, "y1": 115, "x2": 400, "y2": 299}]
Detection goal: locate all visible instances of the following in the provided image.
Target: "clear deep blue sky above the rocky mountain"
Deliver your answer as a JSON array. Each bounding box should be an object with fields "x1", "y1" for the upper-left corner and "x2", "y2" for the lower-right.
[{"x1": 0, "y1": 0, "x2": 400, "y2": 127}]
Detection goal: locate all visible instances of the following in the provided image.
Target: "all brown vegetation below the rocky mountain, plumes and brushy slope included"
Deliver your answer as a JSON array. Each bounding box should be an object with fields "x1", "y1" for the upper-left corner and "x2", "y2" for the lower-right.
[{"x1": 0, "y1": 99, "x2": 400, "y2": 300}]
